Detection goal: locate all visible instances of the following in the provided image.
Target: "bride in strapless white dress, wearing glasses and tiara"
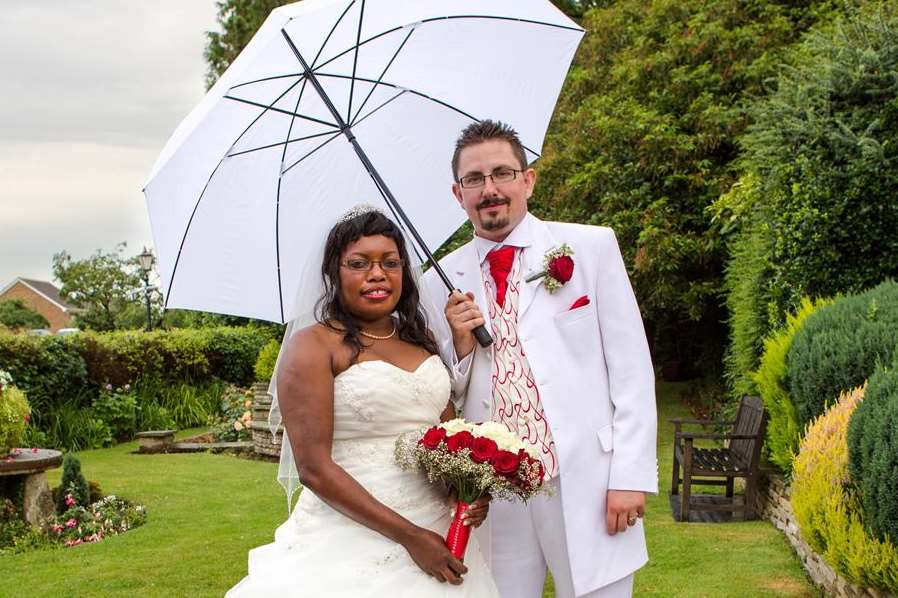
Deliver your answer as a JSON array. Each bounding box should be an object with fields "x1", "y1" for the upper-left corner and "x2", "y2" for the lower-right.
[{"x1": 227, "y1": 210, "x2": 498, "y2": 598}]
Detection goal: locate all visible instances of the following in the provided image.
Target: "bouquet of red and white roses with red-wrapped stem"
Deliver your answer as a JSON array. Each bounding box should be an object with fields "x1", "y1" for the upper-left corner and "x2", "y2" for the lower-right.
[{"x1": 396, "y1": 419, "x2": 544, "y2": 560}]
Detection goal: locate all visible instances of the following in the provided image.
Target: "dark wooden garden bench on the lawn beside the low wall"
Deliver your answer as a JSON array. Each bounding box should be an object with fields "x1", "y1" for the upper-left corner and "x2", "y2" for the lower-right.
[{"x1": 670, "y1": 397, "x2": 767, "y2": 521}]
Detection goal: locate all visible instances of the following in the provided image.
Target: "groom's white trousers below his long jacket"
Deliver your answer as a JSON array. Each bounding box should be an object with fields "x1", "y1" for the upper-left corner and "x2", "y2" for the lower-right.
[{"x1": 484, "y1": 478, "x2": 633, "y2": 598}]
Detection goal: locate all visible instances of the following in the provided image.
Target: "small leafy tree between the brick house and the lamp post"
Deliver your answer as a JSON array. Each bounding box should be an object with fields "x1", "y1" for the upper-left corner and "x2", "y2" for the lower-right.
[{"x1": 53, "y1": 243, "x2": 159, "y2": 330}]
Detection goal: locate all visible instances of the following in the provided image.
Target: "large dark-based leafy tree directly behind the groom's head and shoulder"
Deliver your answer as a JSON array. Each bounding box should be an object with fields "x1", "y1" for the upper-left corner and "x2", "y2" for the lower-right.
[{"x1": 532, "y1": 0, "x2": 830, "y2": 375}]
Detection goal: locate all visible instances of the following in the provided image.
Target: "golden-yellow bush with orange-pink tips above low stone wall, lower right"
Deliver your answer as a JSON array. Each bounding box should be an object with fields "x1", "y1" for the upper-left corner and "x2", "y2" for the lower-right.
[{"x1": 792, "y1": 387, "x2": 898, "y2": 592}]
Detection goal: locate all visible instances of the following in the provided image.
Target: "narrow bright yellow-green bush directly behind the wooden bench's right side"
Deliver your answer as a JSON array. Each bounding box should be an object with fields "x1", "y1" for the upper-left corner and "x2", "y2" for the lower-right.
[{"x1": 752, "y1": 298, "x2": 832, "y2": 475}]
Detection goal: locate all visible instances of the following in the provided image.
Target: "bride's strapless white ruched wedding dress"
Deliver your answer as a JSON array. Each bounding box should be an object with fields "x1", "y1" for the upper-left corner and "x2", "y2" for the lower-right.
[{"x1": 227, "y1": 355, "x2": 499, "y2": 598}]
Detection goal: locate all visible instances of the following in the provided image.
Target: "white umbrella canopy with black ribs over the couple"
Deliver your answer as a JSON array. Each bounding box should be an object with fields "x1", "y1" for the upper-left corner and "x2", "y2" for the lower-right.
[{"x1": 144, "y1": 0, "x2": 583, "y2": 322}]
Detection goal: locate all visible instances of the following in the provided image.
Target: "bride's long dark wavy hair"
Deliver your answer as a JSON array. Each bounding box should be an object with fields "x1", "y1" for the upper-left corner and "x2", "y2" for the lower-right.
[{"x1": 315, "y1": 211, "x2": 438, "y2": 362}]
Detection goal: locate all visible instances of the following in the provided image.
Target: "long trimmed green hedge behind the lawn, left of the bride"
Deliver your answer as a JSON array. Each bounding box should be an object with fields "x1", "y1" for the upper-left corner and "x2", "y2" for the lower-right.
[{"x1": 0, "y1": 326, "x2": 272, "y2": 450}]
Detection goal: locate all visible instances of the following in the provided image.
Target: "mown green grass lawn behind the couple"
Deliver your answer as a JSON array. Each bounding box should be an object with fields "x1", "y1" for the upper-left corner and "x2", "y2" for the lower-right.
[{"x1": 0, "y1": 384, "x2": 816, "y2": 597}]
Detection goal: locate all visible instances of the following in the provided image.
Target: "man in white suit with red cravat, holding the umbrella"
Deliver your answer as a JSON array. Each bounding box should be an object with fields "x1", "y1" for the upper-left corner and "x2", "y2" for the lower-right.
[{"x1": 424, "y1": 121, "x2": 658, "y2": 598}]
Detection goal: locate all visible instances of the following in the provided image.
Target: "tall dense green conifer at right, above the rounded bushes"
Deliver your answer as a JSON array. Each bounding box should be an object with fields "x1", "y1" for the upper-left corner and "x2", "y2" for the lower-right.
[{"x1": 711, "y1": 3, "x2": 898, "y2": 400}]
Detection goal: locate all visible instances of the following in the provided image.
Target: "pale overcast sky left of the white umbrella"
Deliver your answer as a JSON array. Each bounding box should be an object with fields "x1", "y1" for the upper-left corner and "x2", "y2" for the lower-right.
[{"x1": 0, "y1": 0, "x2": 217, "y2": 288}]
